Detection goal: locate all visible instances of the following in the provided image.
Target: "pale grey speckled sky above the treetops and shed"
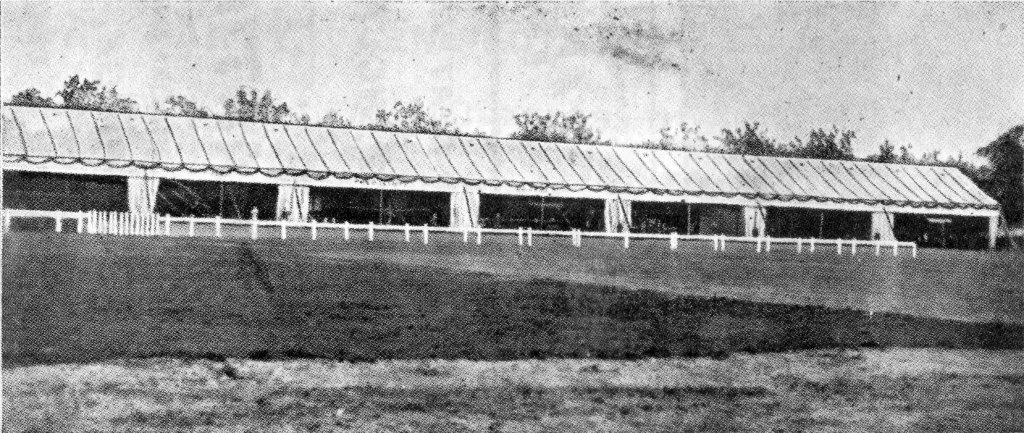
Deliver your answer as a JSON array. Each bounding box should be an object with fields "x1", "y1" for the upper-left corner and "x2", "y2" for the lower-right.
[{"x1": 6, "y1": 2, "x2": 1024, "y2": 156}]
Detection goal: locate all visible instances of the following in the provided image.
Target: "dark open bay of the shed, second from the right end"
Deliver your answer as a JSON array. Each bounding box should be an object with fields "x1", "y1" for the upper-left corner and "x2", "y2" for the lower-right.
[{"x1": 764, "y1": 208, "x2": 871, "y2": 241}]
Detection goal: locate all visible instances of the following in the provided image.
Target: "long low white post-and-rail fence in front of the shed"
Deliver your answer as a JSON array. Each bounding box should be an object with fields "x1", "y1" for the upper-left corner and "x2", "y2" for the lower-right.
[{"x1": 3, "y1": 209, "x2": 918, "y2": 257}]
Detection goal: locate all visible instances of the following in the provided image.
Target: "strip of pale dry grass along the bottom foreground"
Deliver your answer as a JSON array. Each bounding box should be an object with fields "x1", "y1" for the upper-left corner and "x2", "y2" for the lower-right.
[{"x1": 3, "y1": 349, "x2": 1024, "y2": 432}]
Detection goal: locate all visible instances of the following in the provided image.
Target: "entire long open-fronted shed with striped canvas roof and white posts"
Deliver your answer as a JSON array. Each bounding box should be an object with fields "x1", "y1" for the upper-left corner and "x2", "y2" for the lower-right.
[{"x1": 2, "y1": 105, "x2": 998, "y2": 246}]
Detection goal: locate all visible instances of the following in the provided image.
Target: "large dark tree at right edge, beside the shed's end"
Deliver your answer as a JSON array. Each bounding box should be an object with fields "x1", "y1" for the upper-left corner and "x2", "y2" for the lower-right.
[{"x1": 978, "y1": 125, "x2": 1024, "y2": 224}]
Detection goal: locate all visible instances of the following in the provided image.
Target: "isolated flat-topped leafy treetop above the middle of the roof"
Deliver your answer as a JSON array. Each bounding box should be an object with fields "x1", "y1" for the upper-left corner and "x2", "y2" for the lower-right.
[{"x1": 510, "y1": 112, "x2": 608, "y2": 144}]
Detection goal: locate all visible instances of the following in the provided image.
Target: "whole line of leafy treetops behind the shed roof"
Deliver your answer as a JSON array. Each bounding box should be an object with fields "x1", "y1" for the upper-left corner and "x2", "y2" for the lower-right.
[{"x1": 8, "y1": 75, "x2": 1024, "y2": 224}]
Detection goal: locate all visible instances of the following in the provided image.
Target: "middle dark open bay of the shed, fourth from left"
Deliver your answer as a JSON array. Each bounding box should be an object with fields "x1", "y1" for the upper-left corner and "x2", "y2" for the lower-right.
[{"x1": 480, "y1": 194, "x2": 604, "y2": 231}]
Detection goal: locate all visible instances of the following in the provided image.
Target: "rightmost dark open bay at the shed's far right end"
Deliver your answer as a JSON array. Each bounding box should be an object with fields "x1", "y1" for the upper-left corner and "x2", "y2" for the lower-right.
[{"x1": 893, "y1": 214, "x2": 988, "y2": 250}]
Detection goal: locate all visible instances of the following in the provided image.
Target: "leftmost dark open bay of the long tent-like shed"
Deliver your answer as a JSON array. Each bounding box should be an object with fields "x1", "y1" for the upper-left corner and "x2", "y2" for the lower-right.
[{"x1": 3, "y1": 171, "x2": 128, "y2": 212}]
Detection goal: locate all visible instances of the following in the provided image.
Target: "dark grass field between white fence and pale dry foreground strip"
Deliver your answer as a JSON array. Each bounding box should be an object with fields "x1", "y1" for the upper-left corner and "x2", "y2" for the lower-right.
[{"x1": 3, "y1": 232, "x2": 1024, "y2": 366}]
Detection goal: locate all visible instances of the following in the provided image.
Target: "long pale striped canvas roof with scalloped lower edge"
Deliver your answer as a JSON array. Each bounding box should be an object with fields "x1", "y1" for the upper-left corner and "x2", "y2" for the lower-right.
[{"x1": 2, "y1": 106, "x2": 997, "y2": 209}]
